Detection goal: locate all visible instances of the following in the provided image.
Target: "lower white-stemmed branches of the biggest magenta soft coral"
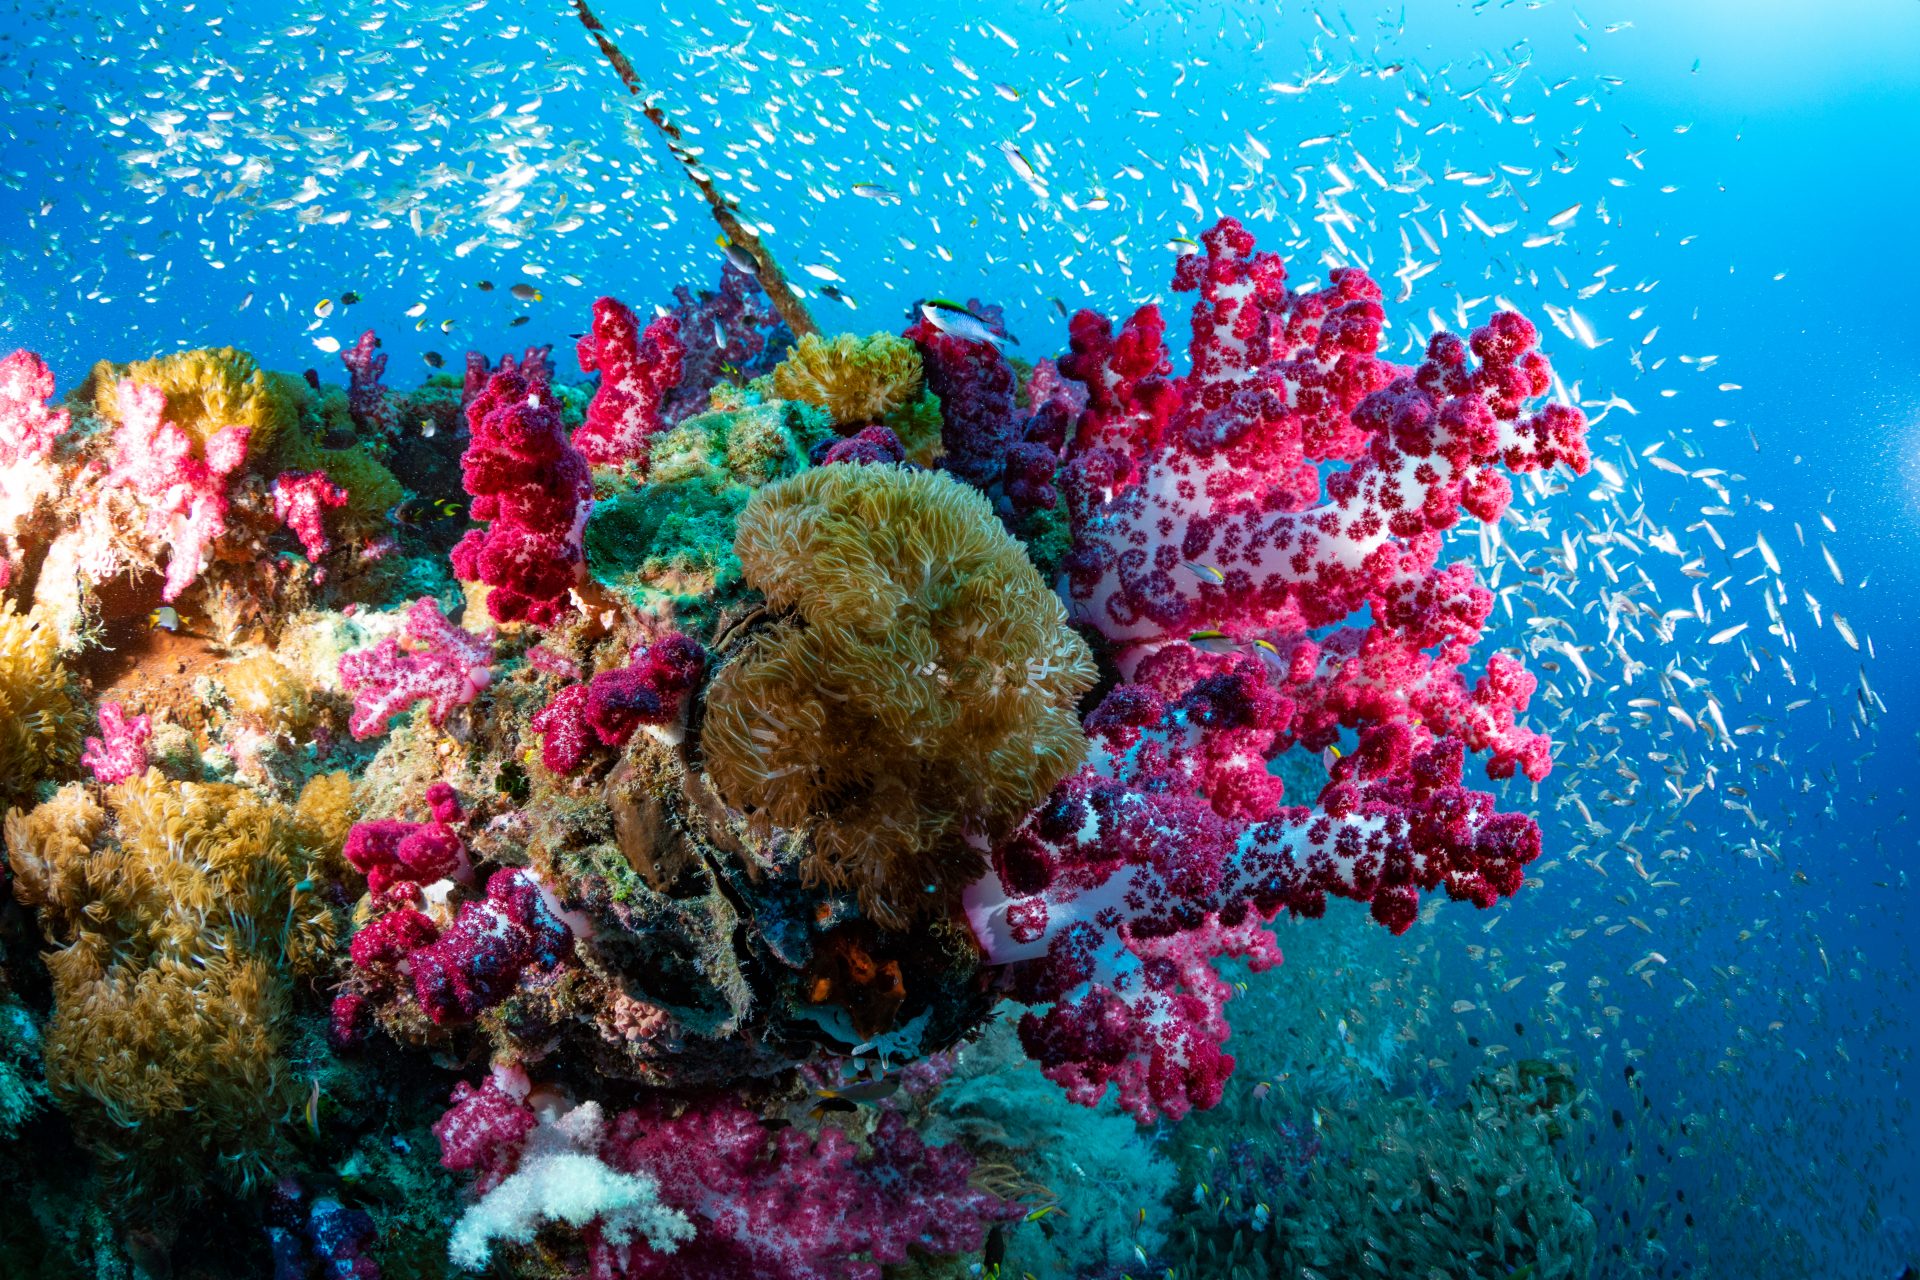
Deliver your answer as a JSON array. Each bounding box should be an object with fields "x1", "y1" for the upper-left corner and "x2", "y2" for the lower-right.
[{"x1": 966, "y1": 677, "x2": 1540, "y2": 1123}]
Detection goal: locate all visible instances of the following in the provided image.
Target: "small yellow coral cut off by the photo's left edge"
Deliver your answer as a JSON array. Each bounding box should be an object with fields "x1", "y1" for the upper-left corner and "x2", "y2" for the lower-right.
[{"x1": 0, "y1": 601, "x2": 88, "y2": 804}]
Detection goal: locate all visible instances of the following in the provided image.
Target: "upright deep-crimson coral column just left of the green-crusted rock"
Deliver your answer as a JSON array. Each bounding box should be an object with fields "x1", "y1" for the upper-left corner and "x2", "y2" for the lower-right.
[{"x1": 451, "y1": 367, "x2": 593, "y2": 626}]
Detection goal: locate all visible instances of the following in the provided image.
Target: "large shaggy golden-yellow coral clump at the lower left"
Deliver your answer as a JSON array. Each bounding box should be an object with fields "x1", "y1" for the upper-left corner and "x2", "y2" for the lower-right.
[{"x1": 6, "y1": 770, "x2": 344, "y2": 1201}]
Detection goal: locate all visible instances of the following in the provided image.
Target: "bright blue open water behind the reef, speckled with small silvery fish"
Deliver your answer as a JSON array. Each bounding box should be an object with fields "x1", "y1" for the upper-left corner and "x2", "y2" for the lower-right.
[{"x1": 0, "y1": 0, "x2": 1920, "y2": 1276}]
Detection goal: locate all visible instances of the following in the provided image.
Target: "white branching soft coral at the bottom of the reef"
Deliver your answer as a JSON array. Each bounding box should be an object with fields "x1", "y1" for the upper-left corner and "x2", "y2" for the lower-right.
[{"x1": 447, "y1": 1102, "x2": 693, "y2": 1270}]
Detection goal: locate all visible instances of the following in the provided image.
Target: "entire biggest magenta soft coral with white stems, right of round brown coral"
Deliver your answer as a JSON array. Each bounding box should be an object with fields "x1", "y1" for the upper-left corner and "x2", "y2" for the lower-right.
[{"x1": 966, "y1": 219, "x2": 1588, "y2": 1121}]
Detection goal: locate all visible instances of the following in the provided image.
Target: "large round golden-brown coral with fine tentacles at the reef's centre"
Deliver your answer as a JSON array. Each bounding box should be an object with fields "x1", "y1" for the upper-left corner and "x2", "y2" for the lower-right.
[{"x1": 701, "y1": 466, "x2": 1094, "y2": 927}]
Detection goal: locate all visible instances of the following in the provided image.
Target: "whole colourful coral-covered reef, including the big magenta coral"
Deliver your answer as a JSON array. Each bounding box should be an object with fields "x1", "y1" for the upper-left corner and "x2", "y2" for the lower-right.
[{"x1": 0, "y1": 202, "x2": 1592, "y2": 1280}]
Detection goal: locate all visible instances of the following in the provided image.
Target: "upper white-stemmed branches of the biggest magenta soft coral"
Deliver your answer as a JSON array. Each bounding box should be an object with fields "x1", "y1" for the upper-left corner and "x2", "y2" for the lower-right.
[{"x1": 1066, "y1": 219, "x2": 1588, "y2": 651}]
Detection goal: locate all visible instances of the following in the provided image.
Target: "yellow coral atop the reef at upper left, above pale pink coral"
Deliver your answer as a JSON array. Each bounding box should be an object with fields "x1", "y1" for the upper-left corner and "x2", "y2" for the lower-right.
[{"x1": 79, "y1": 347, "x2": 305, "y2": 459}]
